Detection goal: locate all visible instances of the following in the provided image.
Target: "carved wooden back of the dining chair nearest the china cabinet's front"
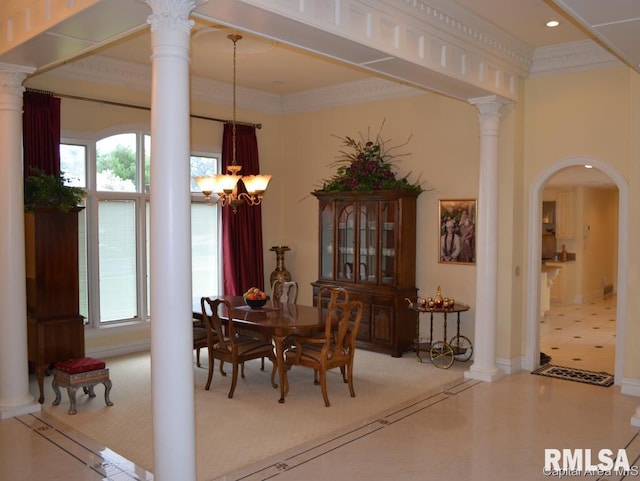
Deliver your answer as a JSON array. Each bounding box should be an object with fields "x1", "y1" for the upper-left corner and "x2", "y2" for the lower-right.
[{"x1": 322, "y1": 301, "x2": 363, "y2": 364}]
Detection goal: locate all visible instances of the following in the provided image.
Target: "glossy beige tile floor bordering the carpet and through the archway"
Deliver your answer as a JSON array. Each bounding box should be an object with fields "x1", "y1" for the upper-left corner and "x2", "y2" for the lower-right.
[{"x1": 6, "y1": 299, "x2": 640, "y2": 481}]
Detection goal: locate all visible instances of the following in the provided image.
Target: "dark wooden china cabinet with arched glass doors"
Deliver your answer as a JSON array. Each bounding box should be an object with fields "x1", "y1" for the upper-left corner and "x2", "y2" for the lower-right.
[{"x1": 312, "y1": 191, "x2": 418, "y2": 357}]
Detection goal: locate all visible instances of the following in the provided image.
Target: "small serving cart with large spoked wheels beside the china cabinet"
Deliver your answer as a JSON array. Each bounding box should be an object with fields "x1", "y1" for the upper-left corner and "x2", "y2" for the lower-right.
[{"x1": 409, "y1": 302, "x2": 473, "y2": 369}]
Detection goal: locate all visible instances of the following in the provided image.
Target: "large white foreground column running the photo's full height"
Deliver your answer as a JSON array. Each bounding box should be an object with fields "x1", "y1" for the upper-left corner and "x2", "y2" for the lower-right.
[{"x1": 147, "y1": 0, "x2": 196, "y2": 481}]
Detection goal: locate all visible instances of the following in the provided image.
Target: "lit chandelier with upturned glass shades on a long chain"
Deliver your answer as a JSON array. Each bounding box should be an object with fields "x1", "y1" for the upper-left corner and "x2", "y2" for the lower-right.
[{"x1": 195, "y1": 33, "x2": 271, "y2": 213}]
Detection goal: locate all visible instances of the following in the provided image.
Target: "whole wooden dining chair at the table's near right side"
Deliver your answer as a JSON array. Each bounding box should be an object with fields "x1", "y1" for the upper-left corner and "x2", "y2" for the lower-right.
[{"x1": 285, "y1": 301, "x2": 363, "y2": 407}]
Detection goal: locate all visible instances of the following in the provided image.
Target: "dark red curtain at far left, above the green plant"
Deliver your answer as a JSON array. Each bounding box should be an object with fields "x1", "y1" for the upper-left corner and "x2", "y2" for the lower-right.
[{"x1": 22, "y1": 90, "x2": 60, "y2": 177}]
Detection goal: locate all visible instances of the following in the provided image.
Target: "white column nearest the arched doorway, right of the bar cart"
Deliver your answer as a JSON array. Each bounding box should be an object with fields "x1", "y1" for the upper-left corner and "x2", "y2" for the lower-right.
[{"x1": 465, "y1": 95, "x2": 505, "y2": 381}]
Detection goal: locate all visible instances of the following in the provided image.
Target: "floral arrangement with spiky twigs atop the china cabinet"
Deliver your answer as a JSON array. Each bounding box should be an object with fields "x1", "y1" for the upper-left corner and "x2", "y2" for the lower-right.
[{"x1": 318, "y1": 123, "x2": 424, "y2": 193}]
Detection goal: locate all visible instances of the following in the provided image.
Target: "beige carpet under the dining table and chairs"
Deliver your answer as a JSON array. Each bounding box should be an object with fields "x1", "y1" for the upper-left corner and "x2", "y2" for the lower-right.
[{"x1": 31, "y1": 350, "x2": 469, "y2": 481}]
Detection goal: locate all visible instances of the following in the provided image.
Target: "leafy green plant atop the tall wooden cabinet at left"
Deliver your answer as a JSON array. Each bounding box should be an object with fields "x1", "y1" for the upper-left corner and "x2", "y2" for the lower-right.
[{"x1": 24, "y1": 167, "x2": 85, "y2": 212}]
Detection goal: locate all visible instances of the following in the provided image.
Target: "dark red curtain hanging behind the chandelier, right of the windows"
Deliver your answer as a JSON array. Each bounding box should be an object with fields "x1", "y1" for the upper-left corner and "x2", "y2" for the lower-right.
[{"x1": 222, "y1": 124, "x2": 264, "y2": 296}]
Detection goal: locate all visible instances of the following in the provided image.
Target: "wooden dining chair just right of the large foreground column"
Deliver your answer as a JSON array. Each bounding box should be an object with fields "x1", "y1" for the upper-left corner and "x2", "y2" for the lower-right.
[{"x1": 200, "y1": 297, "x2": 278, "y2": 398}]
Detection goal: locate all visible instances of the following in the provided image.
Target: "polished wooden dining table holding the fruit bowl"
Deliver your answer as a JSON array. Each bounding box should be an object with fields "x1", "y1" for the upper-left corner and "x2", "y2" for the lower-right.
[{"x1": 193, "y1": 296, "x2": 324, "y2": 403}]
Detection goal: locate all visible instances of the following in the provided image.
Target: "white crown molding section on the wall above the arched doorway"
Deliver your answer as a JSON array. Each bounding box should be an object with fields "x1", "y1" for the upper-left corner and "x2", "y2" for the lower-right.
[{"x1": 529, "y1": 40, "x2": 624, "y2": 78}]
